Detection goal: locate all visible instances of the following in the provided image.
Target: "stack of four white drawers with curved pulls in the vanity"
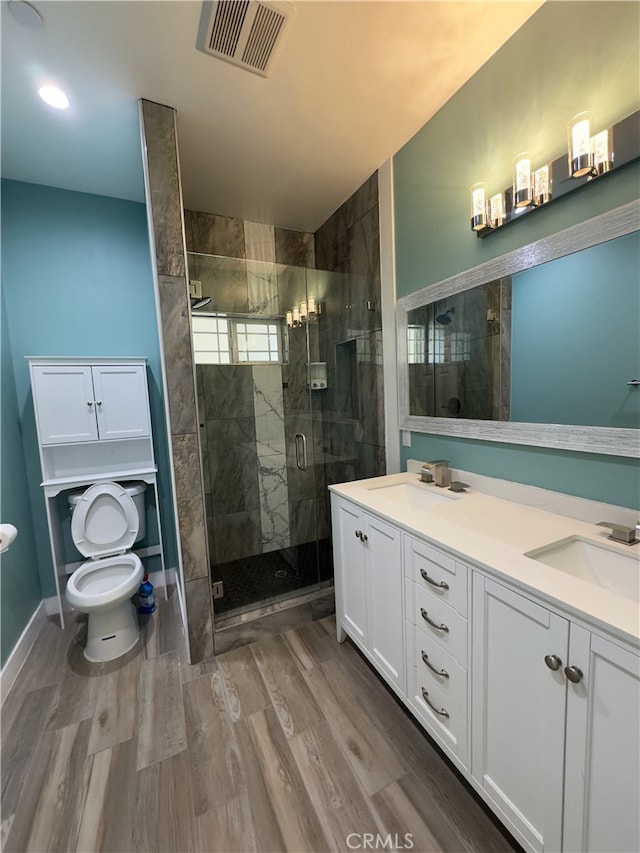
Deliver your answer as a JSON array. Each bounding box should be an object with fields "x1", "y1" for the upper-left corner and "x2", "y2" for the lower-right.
[{"x1": 404, "y1": 534, "x2": 468, "y2": 767}]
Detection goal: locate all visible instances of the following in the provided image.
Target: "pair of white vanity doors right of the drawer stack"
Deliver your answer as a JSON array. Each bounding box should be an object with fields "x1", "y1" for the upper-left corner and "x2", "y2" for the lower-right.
[{"x1": 471, "y1": 573, "x2": 640, "y2": 853}]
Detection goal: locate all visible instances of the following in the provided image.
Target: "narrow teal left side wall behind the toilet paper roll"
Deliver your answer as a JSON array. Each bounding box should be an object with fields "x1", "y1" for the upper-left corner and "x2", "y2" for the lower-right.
[{"x1": 0, "y1": 295, "x2": 42, "y2": 666}]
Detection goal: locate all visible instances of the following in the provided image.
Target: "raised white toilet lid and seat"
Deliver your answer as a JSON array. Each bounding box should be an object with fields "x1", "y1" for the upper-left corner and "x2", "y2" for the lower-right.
[{"x1": 71, "y1": 483, "x2": 139, "y2": 559}]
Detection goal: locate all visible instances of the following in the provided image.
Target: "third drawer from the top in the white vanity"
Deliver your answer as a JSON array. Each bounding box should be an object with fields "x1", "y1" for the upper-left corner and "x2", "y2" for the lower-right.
[{"x1": 407, "y1": 625, "x2": 467, "y2": 717}]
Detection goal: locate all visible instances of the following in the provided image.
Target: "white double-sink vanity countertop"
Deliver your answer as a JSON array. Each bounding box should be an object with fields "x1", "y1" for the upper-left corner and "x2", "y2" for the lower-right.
[{"x1": 329, "y1": 473, "x2": 640, "y2": 645}]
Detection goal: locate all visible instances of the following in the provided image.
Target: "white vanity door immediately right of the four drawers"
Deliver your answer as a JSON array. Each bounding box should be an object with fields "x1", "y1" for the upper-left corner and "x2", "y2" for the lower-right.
[{"x1": 471, "y1": 573, "x2": 569, "y2": 851}]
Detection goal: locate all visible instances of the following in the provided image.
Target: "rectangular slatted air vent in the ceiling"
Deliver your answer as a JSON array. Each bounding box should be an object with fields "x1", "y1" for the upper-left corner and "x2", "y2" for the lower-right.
[{"x1": 198, "y1": 0, "x2": 291, "y2": 77}]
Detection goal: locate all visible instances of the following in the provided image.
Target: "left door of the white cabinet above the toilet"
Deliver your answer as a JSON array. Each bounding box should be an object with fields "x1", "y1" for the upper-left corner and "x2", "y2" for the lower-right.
[{"x1": 32, "y1": 365, "x2": 98, "y2": 444}]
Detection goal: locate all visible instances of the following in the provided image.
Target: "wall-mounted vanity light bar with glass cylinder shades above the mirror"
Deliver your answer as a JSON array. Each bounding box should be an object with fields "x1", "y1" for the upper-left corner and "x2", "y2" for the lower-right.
[{"x1": 470, "y1": 110, "x2": 640, "y2": 237}]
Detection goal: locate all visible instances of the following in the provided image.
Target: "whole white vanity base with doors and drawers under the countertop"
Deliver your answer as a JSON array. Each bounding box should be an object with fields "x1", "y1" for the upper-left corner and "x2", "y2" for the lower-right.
[{"x1": 331, "y1": 492, "x2": 640, "y2": 853}]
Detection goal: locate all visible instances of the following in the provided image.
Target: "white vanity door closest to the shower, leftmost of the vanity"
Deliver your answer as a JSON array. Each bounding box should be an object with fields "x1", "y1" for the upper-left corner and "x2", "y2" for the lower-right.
[{"x1": 333, "y1": 499, "x2": 368, "y2": 648}]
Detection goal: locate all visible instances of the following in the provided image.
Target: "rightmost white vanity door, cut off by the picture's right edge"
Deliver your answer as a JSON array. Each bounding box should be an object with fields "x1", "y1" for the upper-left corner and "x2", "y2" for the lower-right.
[{"x1": 563, "y1": 625, "x2": 640, "y2": 853}]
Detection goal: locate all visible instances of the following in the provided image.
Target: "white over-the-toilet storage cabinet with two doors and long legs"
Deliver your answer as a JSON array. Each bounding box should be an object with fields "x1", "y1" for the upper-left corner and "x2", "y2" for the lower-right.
[{"x1": 29, "y1": 358, "x2": 166, "y2": 625}]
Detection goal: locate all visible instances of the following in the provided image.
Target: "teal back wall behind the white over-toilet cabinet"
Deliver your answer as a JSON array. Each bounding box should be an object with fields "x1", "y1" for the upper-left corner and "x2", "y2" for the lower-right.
[{"x1": 2, "y1": 181, "x2": 177, "y2": 609}]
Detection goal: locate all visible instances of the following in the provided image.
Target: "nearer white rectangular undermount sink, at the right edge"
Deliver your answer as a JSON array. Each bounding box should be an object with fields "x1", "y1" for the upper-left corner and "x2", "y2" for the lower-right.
[{"x1": 524, "y1": 536, "x2": 640, "y2": 601}]
